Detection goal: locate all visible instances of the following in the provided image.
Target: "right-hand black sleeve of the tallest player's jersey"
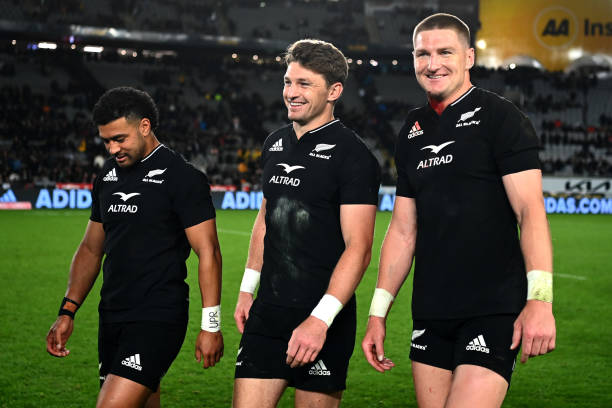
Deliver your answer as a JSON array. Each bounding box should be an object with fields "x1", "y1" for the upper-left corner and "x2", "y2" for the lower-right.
[{"x1": 493, "y1": 100, "x2": 540, "y2": 175}]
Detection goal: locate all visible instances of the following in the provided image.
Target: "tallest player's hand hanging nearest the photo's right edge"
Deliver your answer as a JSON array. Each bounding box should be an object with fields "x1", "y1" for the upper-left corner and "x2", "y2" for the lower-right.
[{"x1": 510, "y1": 300, "x2": 557, "y2": 363}]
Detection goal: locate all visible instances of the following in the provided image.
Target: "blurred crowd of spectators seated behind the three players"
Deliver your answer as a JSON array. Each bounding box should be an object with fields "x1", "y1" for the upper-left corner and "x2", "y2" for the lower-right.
[{"x1": 0, "y1": 47, "x2": 612, "y2": 190}]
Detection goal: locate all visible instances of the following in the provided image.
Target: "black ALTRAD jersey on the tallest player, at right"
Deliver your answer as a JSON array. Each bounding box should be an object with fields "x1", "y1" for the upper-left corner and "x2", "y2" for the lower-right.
[{"x1": 395, "y1": 87, "x2": 540, "y2": 319}]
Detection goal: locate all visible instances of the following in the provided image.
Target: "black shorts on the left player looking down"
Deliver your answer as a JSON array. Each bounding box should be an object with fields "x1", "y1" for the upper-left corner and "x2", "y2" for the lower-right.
[{"x1": 98, "y1": 322, "x2": 187, "y2": 392}]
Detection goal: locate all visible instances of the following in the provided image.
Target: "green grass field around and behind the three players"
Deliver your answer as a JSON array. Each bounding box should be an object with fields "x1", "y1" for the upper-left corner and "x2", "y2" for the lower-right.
[{"x1": 0, "y1": 211, "x2": 612, "y2": 408}]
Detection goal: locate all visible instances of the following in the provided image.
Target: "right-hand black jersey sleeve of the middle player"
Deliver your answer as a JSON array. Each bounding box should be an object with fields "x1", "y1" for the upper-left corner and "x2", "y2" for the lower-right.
[{"x1": 339, "y1": 141, "x2": 380, "y2": 205}]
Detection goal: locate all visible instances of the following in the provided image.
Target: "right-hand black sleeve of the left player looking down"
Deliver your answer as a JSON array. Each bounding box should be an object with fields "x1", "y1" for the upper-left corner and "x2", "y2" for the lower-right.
[{"x1": 172, "y1": 163, "x2": 215, "y2": 228}]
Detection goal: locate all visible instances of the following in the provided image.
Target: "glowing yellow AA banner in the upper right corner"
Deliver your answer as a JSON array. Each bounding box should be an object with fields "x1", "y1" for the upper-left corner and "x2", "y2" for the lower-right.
[{"x1": 476, "y1": 0, "x2": 612, "y2": 71}]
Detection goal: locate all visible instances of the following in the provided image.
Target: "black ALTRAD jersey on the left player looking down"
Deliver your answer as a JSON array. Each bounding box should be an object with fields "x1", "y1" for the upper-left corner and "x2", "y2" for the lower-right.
[{"x1": 90, "y1": 145, "x2": 215, "y2": 323}]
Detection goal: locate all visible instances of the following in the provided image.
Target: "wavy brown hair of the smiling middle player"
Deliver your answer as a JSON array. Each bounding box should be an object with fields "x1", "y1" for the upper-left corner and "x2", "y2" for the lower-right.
[{"x1": 285, "y1": 39, "x2": 348, "y2": 86}]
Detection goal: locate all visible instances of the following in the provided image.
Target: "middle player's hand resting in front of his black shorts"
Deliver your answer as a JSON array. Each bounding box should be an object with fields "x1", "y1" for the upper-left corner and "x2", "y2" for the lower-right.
[{"x1": 287, "y1": 316, "x2": 328, "y2": 368}]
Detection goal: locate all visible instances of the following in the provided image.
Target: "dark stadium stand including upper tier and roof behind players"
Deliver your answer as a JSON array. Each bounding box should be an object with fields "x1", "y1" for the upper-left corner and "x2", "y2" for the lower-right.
[{"x1": 0, "y1": 0, "x2": 612, "y2": 190}]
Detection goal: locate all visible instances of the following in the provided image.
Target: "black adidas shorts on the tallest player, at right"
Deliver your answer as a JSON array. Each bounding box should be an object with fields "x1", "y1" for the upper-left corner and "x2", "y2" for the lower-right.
[{"x1": 410, "y1": 314, "x2": 519, "y2": 385}]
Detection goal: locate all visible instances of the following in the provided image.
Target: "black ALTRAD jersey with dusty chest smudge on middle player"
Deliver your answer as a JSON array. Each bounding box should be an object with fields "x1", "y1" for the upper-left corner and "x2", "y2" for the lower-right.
[{"x1": 258, "y1": 119, "x2": 380, "y2": 308}]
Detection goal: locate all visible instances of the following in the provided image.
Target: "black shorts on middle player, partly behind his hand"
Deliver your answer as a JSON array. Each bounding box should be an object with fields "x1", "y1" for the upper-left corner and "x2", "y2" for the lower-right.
[{"x1": 235, "y1": 298, "x2": 357, "y2": 392}]
